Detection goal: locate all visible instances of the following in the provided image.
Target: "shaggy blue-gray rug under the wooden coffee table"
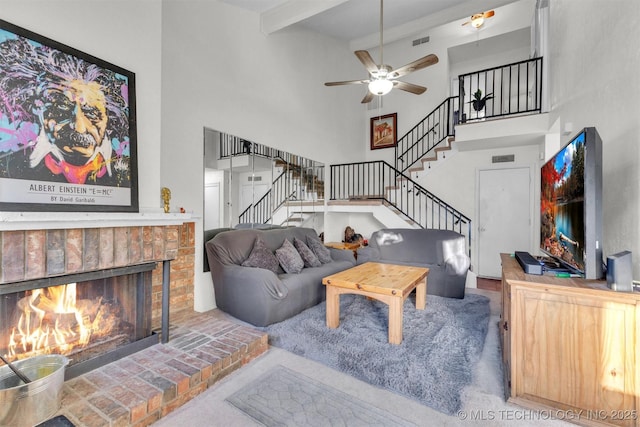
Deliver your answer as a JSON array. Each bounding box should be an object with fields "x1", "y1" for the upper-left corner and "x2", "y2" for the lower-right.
[{"x1": 263, "y1": 293, "x2": 489, "y2": 415}]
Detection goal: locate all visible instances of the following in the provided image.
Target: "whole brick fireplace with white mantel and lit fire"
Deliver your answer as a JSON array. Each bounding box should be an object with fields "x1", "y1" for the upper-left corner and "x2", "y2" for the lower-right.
[{"x1": 0, "y1": 221, "x2": 195, "y2": 379}]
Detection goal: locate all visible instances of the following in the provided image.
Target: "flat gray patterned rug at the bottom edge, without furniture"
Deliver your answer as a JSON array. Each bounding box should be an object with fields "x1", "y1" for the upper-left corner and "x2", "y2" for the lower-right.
[{"x1": 226, "y1": 366, "x2": 413, "y2": 427}]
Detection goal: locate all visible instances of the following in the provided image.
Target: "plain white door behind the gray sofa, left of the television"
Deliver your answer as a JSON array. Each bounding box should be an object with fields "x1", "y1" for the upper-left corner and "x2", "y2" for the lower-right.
[{"x1": 478, "y1": 167, "x2": 533, "y2": 278}]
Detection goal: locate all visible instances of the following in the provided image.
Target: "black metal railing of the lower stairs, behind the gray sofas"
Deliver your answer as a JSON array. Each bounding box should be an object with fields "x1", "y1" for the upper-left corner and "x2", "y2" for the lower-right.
[{"x1": 330, "y1": 160, "x2": 471, "y2": 256}]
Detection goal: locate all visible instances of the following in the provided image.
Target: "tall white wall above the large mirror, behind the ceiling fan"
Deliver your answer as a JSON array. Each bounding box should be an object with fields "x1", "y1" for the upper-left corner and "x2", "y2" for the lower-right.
[{"x1": 161, "y1": 0, "x2": 364, "y2": 311}]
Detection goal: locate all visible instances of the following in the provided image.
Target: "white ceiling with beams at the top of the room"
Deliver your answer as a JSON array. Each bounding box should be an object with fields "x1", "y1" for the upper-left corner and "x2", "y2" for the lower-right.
[{"x1": 222, "y1": 0, "x2": 516, "y2": 49}]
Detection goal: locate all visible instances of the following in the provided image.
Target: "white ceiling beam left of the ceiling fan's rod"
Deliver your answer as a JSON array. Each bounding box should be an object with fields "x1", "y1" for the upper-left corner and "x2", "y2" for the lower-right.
[{"x1": 260, "y1": 0, "x2": 348, "y2": 35}]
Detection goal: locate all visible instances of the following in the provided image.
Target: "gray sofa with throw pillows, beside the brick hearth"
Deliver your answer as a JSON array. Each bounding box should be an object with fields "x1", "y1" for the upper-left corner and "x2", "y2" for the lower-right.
[{"x1": 205, "y1": 227, "x2": 355, "y2": 326}]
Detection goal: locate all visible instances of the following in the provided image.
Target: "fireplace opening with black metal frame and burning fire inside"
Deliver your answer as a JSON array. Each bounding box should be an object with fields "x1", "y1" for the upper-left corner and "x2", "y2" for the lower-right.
[{"x1": 0, "y1": 263, "x2": 158, "y2": 379}]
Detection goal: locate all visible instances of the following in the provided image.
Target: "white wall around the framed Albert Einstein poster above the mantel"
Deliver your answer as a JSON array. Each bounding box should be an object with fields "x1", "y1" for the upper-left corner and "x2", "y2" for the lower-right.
[{"x1": 0, "y1": 0, "x2": 162, "y2": 212}]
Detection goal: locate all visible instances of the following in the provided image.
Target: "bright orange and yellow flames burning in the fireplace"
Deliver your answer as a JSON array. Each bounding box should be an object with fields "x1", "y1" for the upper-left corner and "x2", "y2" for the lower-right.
[{"x1": 8, "y1": 283, "x2": 117, "y2": 359}]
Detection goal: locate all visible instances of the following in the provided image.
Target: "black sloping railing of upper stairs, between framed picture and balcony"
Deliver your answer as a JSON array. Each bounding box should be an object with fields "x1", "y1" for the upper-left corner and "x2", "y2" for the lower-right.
[{"x1": 394, "y1": 96, "x2": 459, "y2": 172}]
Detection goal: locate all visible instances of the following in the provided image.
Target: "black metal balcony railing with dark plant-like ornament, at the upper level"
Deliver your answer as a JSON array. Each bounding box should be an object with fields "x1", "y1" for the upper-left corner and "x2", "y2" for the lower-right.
[{"x1": 457, "y1": 58, "x2": 542, "y2": 123}]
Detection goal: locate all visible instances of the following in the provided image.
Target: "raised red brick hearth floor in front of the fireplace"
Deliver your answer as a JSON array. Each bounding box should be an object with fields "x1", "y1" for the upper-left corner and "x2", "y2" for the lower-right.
[{"x1": 56, "y1": 312, "x2": 268, "y2": 427}]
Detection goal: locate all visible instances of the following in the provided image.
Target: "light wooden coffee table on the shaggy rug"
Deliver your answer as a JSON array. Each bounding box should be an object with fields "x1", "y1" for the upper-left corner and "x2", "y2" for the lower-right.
[{"x1": 322, "y1": 262, "x2": 429, "y2": 344}]
